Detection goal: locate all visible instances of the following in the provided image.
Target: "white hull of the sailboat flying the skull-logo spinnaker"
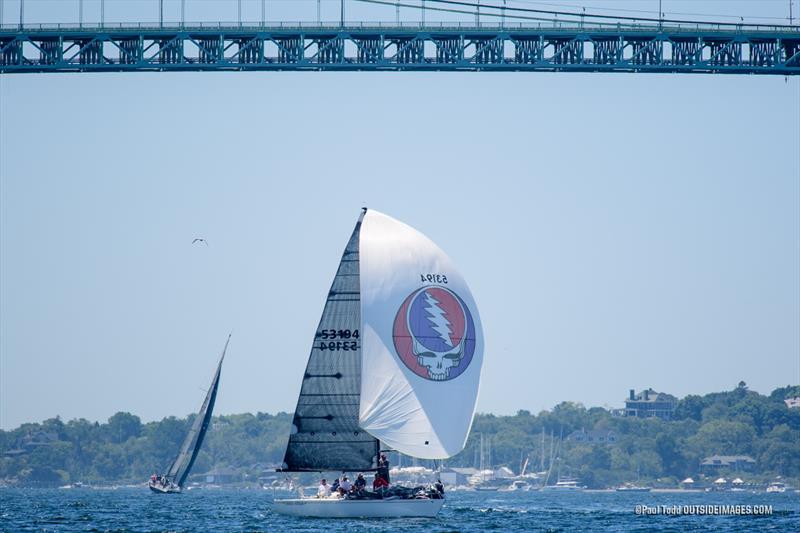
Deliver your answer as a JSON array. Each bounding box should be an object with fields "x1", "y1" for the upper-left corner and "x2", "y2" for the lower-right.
[{"x1": 273, "y1": 498, "x2": 444, "y2": 518}]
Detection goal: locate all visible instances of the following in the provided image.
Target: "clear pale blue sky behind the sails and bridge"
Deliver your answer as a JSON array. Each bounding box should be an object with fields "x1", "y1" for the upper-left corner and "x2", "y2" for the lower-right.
[{"x1": 0, "y1": 0, "x2": 800, "y2": 429}]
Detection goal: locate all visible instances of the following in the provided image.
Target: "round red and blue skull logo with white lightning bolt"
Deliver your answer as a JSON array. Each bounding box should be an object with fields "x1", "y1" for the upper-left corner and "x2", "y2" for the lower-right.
[{"x1": 393, "y1": 285, "x2": 475, "y2": 381}]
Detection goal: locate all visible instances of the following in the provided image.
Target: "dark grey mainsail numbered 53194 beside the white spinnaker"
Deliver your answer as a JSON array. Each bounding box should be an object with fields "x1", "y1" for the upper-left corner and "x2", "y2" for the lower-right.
[{"x1": 281, "y1": 209, "x2": 379, "y2": 472}]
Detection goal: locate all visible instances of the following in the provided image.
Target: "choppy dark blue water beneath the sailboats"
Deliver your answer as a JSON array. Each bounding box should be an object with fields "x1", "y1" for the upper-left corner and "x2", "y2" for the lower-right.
[{"x1": 0, "y1": 487, "x2": 800, "y2": 533}]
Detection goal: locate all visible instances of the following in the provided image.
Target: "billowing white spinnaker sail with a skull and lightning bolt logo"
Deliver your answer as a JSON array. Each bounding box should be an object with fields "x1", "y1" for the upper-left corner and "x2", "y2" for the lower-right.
[{"x1": 359, "y1": 209, "x2": 483, "y2": 459}]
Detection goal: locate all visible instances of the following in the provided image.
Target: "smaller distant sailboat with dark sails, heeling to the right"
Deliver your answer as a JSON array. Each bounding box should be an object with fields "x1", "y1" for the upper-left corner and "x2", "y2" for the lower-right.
[{"x1": 148, "y1": 335, "x2": 231, "y2": 494}]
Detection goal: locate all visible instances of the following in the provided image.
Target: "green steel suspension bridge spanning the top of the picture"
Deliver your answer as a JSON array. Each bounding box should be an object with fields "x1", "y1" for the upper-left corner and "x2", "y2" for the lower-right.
[{"x1": 0, "y1": 0, "x2": 800, "y2": 76}]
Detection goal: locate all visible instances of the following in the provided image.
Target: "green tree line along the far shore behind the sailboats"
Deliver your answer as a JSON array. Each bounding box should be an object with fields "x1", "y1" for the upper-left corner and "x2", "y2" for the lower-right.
[{"x1": 0, "y1": 383, "x2": 800, "y2": 487}]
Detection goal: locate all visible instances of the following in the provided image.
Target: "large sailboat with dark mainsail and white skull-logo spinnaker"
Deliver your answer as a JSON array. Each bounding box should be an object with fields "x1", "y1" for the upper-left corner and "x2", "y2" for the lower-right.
[{"x1": 273, "y1": 208, "x2": 483, "y2": 517}]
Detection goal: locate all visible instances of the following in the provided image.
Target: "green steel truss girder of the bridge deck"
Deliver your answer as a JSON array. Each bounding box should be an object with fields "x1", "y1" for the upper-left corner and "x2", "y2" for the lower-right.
[{"x1": 0, "y1": 27, "x2": 800, "y2": 75}]
